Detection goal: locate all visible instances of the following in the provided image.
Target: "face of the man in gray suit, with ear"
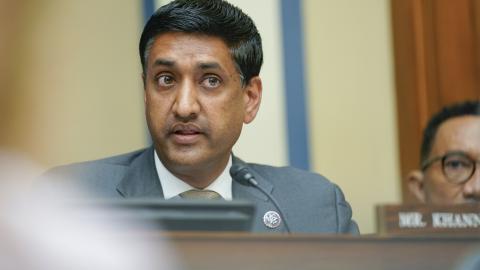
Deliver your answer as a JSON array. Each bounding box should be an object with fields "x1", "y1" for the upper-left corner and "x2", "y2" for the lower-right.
[{"x1": 144, "y1": 33, "x2": 261, "y2": 187}]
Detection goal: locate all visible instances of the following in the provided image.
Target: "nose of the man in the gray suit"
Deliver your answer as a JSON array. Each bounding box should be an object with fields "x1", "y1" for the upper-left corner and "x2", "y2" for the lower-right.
[{"x1": 172, "y1": 81, "x2": 200, "y2": 122}]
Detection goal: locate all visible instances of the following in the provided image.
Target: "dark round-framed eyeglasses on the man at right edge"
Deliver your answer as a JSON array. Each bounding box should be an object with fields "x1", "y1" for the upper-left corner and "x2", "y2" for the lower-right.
[{"x1": 422, "y1": 152, "x2": 480, "y2": 184}]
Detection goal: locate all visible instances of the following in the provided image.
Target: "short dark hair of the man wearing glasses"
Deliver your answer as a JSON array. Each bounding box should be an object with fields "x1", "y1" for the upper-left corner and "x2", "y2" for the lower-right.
[{"x1": 420, "y1": 100, "x2": 480, "y2": 163}]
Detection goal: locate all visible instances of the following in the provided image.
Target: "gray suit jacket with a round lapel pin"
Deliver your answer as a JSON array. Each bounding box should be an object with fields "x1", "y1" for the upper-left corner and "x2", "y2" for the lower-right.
[{"x1": 46, "y1": 147, "x2": 358, "y2": 234}]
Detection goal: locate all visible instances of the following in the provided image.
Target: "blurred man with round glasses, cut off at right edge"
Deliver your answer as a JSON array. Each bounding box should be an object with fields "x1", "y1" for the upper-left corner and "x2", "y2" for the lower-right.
[{"x1": 408, "y1": 101, "x2": 480, "y2": 204}]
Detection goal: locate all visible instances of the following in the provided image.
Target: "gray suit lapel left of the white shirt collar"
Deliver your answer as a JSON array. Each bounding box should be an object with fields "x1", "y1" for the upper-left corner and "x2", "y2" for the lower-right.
[{"x1": 117, "y1": 147, "x2": 163, "y2": 198}]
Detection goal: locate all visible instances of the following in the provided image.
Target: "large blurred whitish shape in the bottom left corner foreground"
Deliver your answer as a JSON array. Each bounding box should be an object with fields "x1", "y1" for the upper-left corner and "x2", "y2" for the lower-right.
[{"x1": 0, "y1": 153, "x2": 177, "y2": 270}]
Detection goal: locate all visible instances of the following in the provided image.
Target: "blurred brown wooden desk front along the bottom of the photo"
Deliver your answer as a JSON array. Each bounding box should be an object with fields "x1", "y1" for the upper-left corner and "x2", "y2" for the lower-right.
[{"x1": 145, "y1": 234, "x2": 480, "y2": 270}]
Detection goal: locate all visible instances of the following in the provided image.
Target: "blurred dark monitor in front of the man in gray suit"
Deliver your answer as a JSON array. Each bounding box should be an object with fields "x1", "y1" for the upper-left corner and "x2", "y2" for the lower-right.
[{"x1": 77, "y1": 198, "x2": 255, "y2": 232}]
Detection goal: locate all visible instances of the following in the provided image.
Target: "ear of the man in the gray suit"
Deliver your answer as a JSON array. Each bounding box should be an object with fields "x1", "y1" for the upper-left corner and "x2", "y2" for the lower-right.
[{"x1": 243, "y1": 76, "x2": 262, "y2": 124}]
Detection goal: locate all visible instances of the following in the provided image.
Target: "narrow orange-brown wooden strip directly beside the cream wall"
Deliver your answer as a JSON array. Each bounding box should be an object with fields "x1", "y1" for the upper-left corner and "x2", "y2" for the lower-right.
[{"x1": 391, "y1": 0, "x2": 426, "y2": 201}]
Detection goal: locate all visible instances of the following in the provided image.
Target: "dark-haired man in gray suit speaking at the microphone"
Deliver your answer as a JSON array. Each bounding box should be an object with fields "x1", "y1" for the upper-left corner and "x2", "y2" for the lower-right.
[{"x1": 47, "y1": 0, "x2": 358, "y2": 234}]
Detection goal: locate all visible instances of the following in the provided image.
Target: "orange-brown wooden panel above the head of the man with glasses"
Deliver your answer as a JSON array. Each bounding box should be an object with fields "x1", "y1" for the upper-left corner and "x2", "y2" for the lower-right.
[{"x1": 430, "y1": 0, "x2": 480, "y2": 104}]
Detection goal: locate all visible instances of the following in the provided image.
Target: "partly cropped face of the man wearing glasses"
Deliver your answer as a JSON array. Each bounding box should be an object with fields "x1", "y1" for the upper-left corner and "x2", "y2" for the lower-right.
[{"x1": 408, "y1": 116, "x2": 480, "y2": 204}]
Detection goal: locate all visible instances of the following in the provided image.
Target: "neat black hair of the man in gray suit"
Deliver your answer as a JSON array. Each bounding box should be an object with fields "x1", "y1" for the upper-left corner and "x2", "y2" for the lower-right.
[{"x1": 139, "y1": 0, "x2": 263, "y2": 84}]
